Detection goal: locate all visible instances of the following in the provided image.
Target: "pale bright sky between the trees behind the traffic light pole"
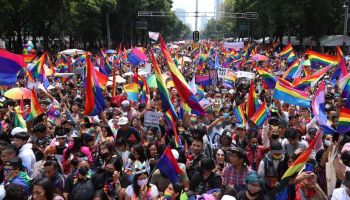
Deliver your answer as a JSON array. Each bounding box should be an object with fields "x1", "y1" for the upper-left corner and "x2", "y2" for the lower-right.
[{"x1": 172, "y1": 0, "x2": 215, "y2": 30}]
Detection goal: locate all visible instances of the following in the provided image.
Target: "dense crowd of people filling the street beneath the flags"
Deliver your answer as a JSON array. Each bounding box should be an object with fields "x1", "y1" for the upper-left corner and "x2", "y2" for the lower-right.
[{"x1": 0, "y1": 39, "x2": 350, "y2": 200}]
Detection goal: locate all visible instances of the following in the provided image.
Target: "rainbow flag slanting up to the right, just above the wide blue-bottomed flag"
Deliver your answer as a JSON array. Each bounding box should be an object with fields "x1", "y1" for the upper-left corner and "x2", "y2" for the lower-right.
[{"x1": 293, "y1": 66, "x2": 332, "y2": 90}]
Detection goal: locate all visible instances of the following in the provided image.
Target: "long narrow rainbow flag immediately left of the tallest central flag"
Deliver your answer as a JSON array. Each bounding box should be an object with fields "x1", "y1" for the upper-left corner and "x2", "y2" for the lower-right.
[{"x1": 151, "y1": 51, "x2": 177, "y2": 118}]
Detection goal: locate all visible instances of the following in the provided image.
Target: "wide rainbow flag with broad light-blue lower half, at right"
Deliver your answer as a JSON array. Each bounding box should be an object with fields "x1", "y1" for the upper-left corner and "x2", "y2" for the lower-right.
[{"x1": 273, "y1": 82, "x2": 311, "y2": 108}]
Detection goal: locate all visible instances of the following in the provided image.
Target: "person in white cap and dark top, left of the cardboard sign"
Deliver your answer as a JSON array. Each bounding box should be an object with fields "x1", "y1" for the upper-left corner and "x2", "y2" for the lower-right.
[{"x1": 116, "y1": 117, "x2": 141, "y2": 145}]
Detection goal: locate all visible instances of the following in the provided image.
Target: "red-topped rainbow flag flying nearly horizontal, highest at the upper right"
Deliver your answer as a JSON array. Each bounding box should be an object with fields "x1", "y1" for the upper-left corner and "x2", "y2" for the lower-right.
[{"x1": 306, "y1": 50, "x2": 339, "y2": 68}]
